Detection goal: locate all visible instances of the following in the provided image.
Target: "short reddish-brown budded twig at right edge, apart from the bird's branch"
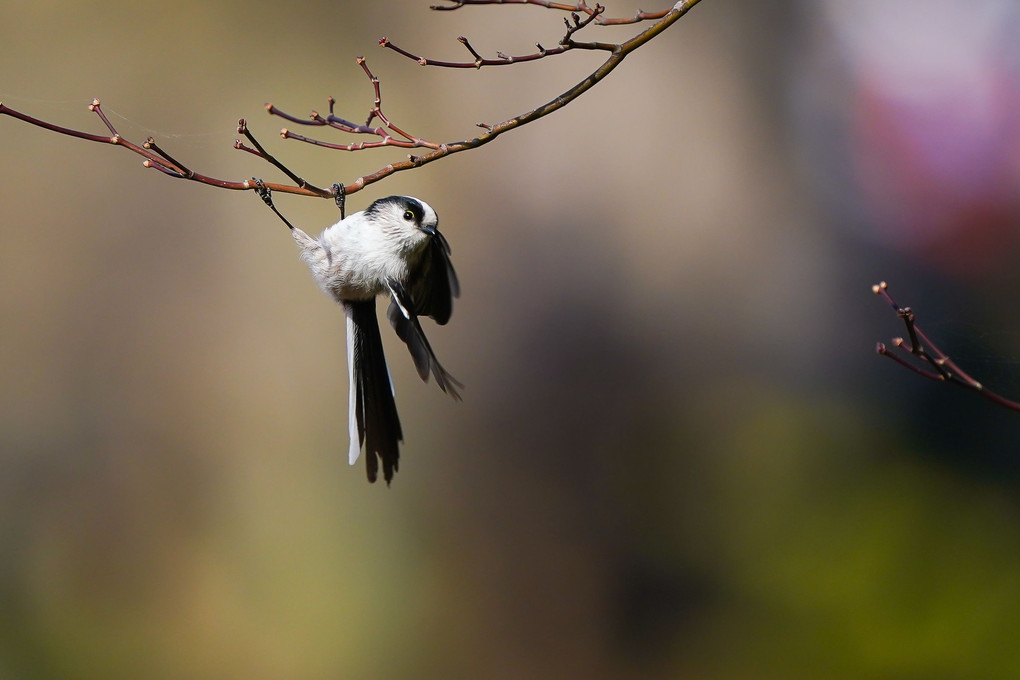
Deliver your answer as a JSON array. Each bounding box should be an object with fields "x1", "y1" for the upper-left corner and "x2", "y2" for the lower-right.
[{"x1": 871, "y1": 281, "x2": 1020, "y2": 411}]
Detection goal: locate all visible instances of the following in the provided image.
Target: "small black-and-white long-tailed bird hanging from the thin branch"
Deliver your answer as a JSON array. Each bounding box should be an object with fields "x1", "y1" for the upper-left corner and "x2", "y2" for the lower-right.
[{"x1": 256, "y1": 180, "x2": 463, "y2": 484}]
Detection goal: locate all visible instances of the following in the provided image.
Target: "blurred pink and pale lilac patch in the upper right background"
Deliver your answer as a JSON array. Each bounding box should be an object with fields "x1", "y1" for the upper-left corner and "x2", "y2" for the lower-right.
[{"x1": 809, "y1": 1, "x2": 1020, "y2": 280}]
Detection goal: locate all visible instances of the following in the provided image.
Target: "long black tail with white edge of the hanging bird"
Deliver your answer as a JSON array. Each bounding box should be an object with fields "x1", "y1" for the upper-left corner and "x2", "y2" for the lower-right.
[{"x1": 344, "y1": 298, "x2": 404, "y2": 484}]
